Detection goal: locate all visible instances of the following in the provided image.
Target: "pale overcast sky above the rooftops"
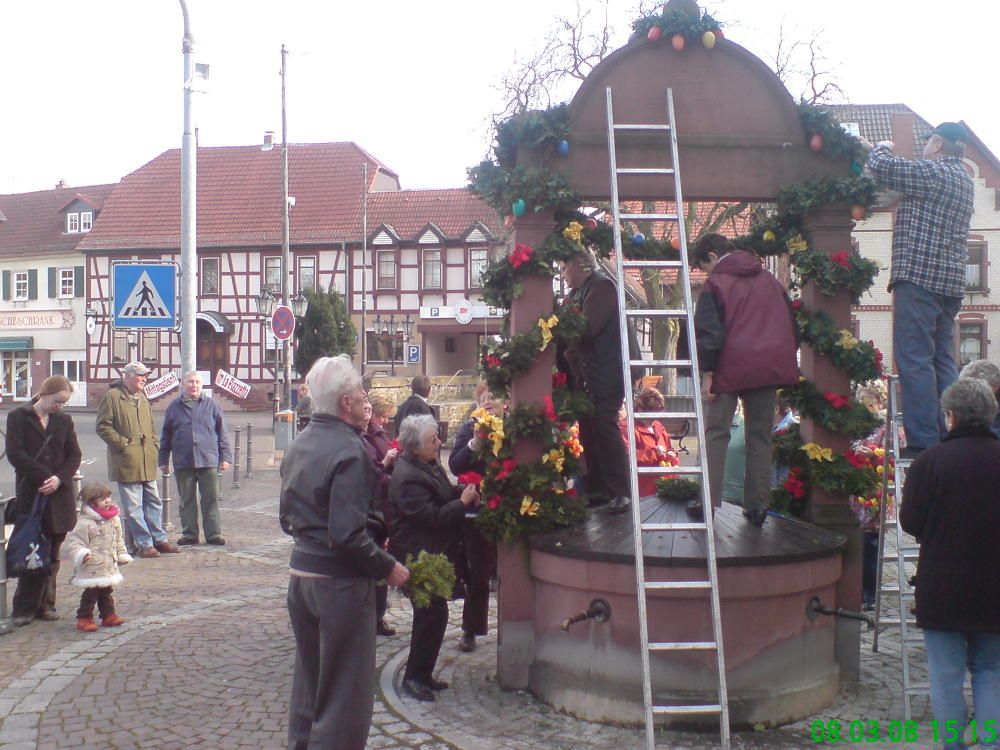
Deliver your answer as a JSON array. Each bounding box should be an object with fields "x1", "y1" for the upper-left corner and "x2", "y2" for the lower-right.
[{"x1": 0, "y1": 0, "x2": 1000, "y2": 193}]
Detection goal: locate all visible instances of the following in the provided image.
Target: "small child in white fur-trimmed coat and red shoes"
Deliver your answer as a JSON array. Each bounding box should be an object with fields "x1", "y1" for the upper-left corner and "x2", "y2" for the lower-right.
[{"x1": 63, "y1": 482, "x2": 132, "y2": 633}]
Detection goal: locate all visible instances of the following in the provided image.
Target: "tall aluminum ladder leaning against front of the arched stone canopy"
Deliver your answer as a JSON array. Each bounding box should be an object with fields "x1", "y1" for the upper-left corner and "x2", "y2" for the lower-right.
[{"x1": 607, "y1": 87, "x2": 730, "y2": 750}]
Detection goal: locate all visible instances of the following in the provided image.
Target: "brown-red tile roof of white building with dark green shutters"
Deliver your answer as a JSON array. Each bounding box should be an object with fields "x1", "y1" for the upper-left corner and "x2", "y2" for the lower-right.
[{"x1": 0, "y1": 185, "x2": 115, "y2": 258}]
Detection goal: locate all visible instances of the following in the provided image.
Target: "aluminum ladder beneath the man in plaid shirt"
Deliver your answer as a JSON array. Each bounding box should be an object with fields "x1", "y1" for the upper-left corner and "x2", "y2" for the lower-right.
[{"x1": 872, "y1": 375, "x2": 930, "y2": 721}]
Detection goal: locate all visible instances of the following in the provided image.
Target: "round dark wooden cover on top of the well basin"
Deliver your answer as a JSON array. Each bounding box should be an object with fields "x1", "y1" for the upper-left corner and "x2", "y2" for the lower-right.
[{"x1": 530, "y1": 497, "x2": 846, "y2": 567}]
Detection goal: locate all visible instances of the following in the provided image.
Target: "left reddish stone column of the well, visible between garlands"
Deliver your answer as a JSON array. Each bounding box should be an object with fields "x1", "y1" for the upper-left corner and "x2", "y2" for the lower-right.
[{"x1": 497, "y1": 211, "x2": 555, "y2": 689}]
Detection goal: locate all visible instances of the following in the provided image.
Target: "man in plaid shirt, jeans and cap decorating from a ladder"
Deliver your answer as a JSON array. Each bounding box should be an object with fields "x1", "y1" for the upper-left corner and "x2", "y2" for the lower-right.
[{"x1": 867, "y1": 122, "x2": 973, "y2": 457}]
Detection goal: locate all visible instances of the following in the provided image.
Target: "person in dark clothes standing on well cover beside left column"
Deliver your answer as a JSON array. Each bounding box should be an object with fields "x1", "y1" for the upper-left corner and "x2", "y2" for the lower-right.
[{"x1": 559, "y1": 251, "x2": 632, "y2": 513}]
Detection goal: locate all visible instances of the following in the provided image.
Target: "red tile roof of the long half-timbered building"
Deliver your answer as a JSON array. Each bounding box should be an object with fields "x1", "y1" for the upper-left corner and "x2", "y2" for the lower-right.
[{"x1": 81, "y1": 143, "x2": 496, "y2": 250}]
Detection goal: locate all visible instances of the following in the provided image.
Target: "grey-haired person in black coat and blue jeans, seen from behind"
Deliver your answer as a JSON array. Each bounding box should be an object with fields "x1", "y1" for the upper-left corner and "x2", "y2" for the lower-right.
[{"x1": 899, "y1": 378, "x2": 1000, "y2": 748}]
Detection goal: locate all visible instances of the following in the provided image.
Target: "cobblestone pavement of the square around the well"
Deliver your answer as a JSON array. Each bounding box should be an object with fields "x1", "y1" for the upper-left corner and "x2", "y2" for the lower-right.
[{"x1": 0, "y1": 470, "x2": 948, "y2": 750}]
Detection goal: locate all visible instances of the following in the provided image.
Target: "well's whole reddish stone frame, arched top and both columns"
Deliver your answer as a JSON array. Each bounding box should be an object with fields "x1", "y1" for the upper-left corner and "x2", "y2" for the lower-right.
[{"x1": 498, "y1": 7, "x2": 861, "y2": 700}]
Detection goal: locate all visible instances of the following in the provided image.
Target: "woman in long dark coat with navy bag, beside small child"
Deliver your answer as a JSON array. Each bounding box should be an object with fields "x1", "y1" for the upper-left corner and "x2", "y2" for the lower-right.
[{"x1": 7, "y1": 375, "x2": 81, "y2": 627}]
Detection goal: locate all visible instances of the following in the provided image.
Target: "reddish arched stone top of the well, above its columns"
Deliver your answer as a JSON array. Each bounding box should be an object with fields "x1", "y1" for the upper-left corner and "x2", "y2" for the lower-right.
[{"x1": 524, "y1": 38, "x2": 849, "y2": 202}]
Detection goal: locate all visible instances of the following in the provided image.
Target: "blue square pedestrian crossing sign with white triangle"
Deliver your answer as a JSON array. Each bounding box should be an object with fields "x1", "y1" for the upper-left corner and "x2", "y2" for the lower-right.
[{"x1": 111, "y1": 263, "x2": 177, "y2": 329}]
